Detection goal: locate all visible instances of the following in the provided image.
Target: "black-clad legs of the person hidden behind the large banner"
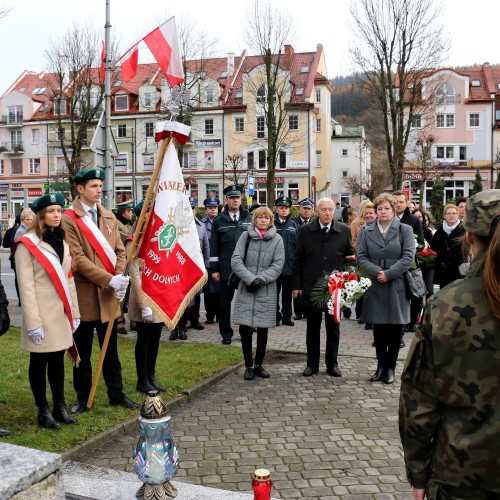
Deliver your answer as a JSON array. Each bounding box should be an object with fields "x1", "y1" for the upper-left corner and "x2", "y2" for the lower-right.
[{"x1": 135, "y1": 321, "x2": 163, "y2": 381}]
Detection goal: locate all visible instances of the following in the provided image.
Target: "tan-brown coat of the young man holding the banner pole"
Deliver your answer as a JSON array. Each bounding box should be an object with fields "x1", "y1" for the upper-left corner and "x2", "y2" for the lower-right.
[{"x1": 61, "y1": 197, "x2": 126, "y2": 323}]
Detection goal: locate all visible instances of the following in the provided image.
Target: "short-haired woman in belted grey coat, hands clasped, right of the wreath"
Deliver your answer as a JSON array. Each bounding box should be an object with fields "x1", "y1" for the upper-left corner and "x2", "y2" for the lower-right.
[{"x1": 357, "y1": 193, "x2": 416, "y2": 384}]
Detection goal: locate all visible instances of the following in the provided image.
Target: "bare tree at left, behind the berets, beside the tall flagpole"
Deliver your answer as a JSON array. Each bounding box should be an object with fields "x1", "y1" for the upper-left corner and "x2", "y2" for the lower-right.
[{"x1": 45, "y1": 24, "x2": 115, "y2": 196}]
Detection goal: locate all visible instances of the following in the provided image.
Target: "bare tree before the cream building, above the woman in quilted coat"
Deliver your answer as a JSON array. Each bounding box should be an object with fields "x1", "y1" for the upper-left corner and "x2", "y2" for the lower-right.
[{"x1": 246, "y1": 0, "x2": 294, "y2": 207}]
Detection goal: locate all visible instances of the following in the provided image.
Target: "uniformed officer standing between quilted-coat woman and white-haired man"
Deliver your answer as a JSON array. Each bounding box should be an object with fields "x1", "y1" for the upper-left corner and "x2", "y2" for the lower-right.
[{"x1": 274, "y1": 196, "x2": 299, "y2": 326}]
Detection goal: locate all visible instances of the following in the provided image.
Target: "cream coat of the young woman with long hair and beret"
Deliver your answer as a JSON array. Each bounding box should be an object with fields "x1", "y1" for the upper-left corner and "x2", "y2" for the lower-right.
[{"x1": 16, "y1": 237, "x2": 80, "y2": 352}]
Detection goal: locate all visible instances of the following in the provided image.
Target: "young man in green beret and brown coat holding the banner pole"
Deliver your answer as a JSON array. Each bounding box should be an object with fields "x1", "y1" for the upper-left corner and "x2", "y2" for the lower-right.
[{"x1": 61, "y1": 168, "x2": 140, "y2": 413}]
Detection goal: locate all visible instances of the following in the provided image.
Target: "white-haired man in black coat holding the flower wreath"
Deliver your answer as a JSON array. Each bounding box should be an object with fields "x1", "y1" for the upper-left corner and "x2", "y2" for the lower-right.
[{"x1": 293, "y1": 198, "x2": 354, "y2": 377}]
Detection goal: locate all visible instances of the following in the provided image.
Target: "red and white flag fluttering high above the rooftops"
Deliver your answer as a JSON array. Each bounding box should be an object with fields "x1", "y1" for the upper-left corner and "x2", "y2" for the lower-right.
[{"x1": 120, "y1": 17, "x2": 184, "y2": 87}]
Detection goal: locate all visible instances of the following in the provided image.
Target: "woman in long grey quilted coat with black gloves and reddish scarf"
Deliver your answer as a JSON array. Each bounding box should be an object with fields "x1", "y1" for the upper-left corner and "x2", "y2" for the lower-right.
[{"x1": 231, "y1": 207, "x2": 285, "y2": 380}]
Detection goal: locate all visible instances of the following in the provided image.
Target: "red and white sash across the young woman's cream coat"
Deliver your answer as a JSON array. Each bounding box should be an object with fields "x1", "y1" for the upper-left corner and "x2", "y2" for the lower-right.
[{"x1": 18, "y1": 233, "x2": 73, "y2": 331}]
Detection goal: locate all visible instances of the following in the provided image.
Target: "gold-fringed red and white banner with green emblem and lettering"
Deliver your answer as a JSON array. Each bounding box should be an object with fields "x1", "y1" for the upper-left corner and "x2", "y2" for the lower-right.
[{"x1": 138, "y1": 141, "x2": 208, "y2": 330}]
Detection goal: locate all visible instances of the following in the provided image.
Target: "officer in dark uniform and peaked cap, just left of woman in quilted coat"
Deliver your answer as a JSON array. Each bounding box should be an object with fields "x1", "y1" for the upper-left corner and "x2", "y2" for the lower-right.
[{"x1": 210, "y1": 185, "x2": 252, "y2": 344}]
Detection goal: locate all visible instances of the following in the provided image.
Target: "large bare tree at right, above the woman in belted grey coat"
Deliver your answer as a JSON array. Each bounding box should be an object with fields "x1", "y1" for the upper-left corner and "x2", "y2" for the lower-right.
[{"x1": 350, "y1": 0, "x2": 447, "y2": 189}]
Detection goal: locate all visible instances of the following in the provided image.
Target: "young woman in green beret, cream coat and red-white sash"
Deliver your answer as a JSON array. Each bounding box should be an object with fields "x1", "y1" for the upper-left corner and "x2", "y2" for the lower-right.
[{"x1": 16, "y1": 193, "x2": 80, "y2": 429}]
